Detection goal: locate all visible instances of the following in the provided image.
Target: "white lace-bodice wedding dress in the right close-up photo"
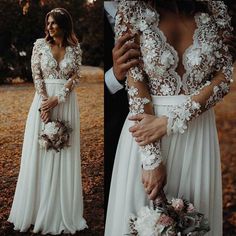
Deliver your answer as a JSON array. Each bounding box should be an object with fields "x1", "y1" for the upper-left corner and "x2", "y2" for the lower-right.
[{"x1": 105, "y1": 1, "x2": 233, "y2": 236}]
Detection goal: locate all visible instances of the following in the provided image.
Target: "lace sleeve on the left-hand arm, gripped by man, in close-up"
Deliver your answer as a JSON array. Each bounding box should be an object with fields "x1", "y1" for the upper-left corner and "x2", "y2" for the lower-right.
[{"x1": 115, "y1": 1, "x2": 162, "y2": 170}]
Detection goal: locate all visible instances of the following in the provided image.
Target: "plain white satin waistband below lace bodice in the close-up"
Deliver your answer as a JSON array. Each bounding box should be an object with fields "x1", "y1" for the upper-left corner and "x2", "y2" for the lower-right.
[{"x1": 151, "y1": 95, "x2": 188, "y2": 106}]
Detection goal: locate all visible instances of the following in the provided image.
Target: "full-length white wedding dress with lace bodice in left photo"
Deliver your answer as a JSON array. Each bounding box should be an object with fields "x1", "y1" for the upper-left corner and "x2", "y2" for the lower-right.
[{"x1": 8, "y1": 39, "x2": 87, "y2": 234}]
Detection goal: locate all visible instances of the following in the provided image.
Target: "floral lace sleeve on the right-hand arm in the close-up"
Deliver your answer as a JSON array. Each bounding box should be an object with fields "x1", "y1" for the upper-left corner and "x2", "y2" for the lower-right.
[{"x1": 167, "y1": 1, "x2": 233, "y2": 135}]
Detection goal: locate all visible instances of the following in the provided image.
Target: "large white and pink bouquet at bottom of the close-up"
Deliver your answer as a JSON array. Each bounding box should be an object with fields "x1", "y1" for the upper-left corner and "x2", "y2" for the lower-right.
[{"x1": 129, "y1": 194, "x2": 210, "y2": 236}]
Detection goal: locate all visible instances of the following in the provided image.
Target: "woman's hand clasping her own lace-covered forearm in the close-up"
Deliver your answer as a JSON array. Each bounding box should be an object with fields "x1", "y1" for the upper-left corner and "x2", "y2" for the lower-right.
[{"x1": 129, "y1": 114, "x2": 168, "y2": 146}]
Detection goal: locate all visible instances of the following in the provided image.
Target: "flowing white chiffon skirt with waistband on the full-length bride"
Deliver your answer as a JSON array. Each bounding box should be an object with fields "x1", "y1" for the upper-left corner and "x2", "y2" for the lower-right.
[{"x1": 8, "y1": 79, "x2": 87, "y2": 234}]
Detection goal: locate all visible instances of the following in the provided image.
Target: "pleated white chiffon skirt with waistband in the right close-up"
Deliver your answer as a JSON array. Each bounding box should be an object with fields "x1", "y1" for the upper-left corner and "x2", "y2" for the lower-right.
[{"x1": 105, "y1": 95, "x2": 222, "y2": 236}]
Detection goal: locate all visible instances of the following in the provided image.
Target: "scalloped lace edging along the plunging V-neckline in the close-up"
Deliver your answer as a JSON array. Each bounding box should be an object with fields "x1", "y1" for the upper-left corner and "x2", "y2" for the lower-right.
[{"x1": 148, "y1": 3, "x2": 200, "y2": 79}]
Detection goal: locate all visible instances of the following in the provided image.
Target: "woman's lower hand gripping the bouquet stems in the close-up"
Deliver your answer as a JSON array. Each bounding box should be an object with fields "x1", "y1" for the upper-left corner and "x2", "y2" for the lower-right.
[{"x1": 142, "y1": 163, "x2": 166, "y2": 200}]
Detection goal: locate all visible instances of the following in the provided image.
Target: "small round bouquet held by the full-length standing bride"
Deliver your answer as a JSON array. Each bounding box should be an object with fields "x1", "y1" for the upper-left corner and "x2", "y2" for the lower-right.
[{"x1": 39, "y1": 120, "x2": 72, "y2": 152}]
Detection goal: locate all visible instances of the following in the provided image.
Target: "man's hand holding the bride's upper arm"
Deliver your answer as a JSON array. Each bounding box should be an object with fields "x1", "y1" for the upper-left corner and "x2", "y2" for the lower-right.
[{"x1": 112, "y1": 33, "x2": 140, "y2": 81}]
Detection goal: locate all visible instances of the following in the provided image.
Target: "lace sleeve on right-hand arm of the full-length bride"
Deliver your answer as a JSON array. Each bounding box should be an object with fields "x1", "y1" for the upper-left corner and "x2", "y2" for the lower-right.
[{"x1": 56, "y1": 44, "x2": 82, "y2": 104}]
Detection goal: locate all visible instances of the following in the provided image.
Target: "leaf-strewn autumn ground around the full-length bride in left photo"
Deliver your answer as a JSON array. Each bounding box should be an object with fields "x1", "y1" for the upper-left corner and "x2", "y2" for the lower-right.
[{"x1": 0, "y1": 68, "x2": 104, "y2": 236}]
